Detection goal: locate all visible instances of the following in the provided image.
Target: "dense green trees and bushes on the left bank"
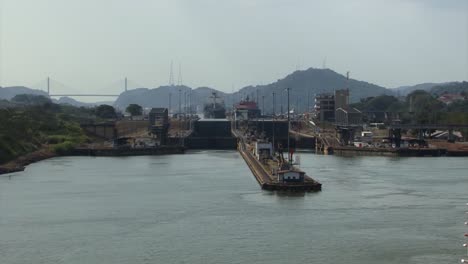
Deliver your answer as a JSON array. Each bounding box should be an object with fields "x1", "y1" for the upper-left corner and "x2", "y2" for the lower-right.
[{"x1": 0, "y1": 95, "x2": 95, "y2": 163}]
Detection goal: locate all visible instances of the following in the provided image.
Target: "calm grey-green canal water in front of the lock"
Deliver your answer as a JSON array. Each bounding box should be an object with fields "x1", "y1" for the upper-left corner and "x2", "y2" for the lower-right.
[{"x1": 0, "y1": 151, "x2": 468, "y2": 264}]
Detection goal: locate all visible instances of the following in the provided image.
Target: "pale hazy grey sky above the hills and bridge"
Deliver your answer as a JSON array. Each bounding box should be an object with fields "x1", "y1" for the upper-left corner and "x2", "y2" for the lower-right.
[{"x1": 0, "y1": 0, "x2": 468, "y2": 97}]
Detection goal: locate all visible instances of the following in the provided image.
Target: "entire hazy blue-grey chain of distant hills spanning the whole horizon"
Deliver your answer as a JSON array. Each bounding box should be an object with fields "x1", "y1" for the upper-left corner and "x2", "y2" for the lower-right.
[{"x1": 0, "y1": 68, "x2": 464, "y2": 113}]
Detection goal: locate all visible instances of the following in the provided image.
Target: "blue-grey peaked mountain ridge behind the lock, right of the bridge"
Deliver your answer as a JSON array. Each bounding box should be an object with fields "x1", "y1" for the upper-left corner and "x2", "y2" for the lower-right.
[{"x1": 114, "y1": 68, "x2": 392, "y2": 112}]
